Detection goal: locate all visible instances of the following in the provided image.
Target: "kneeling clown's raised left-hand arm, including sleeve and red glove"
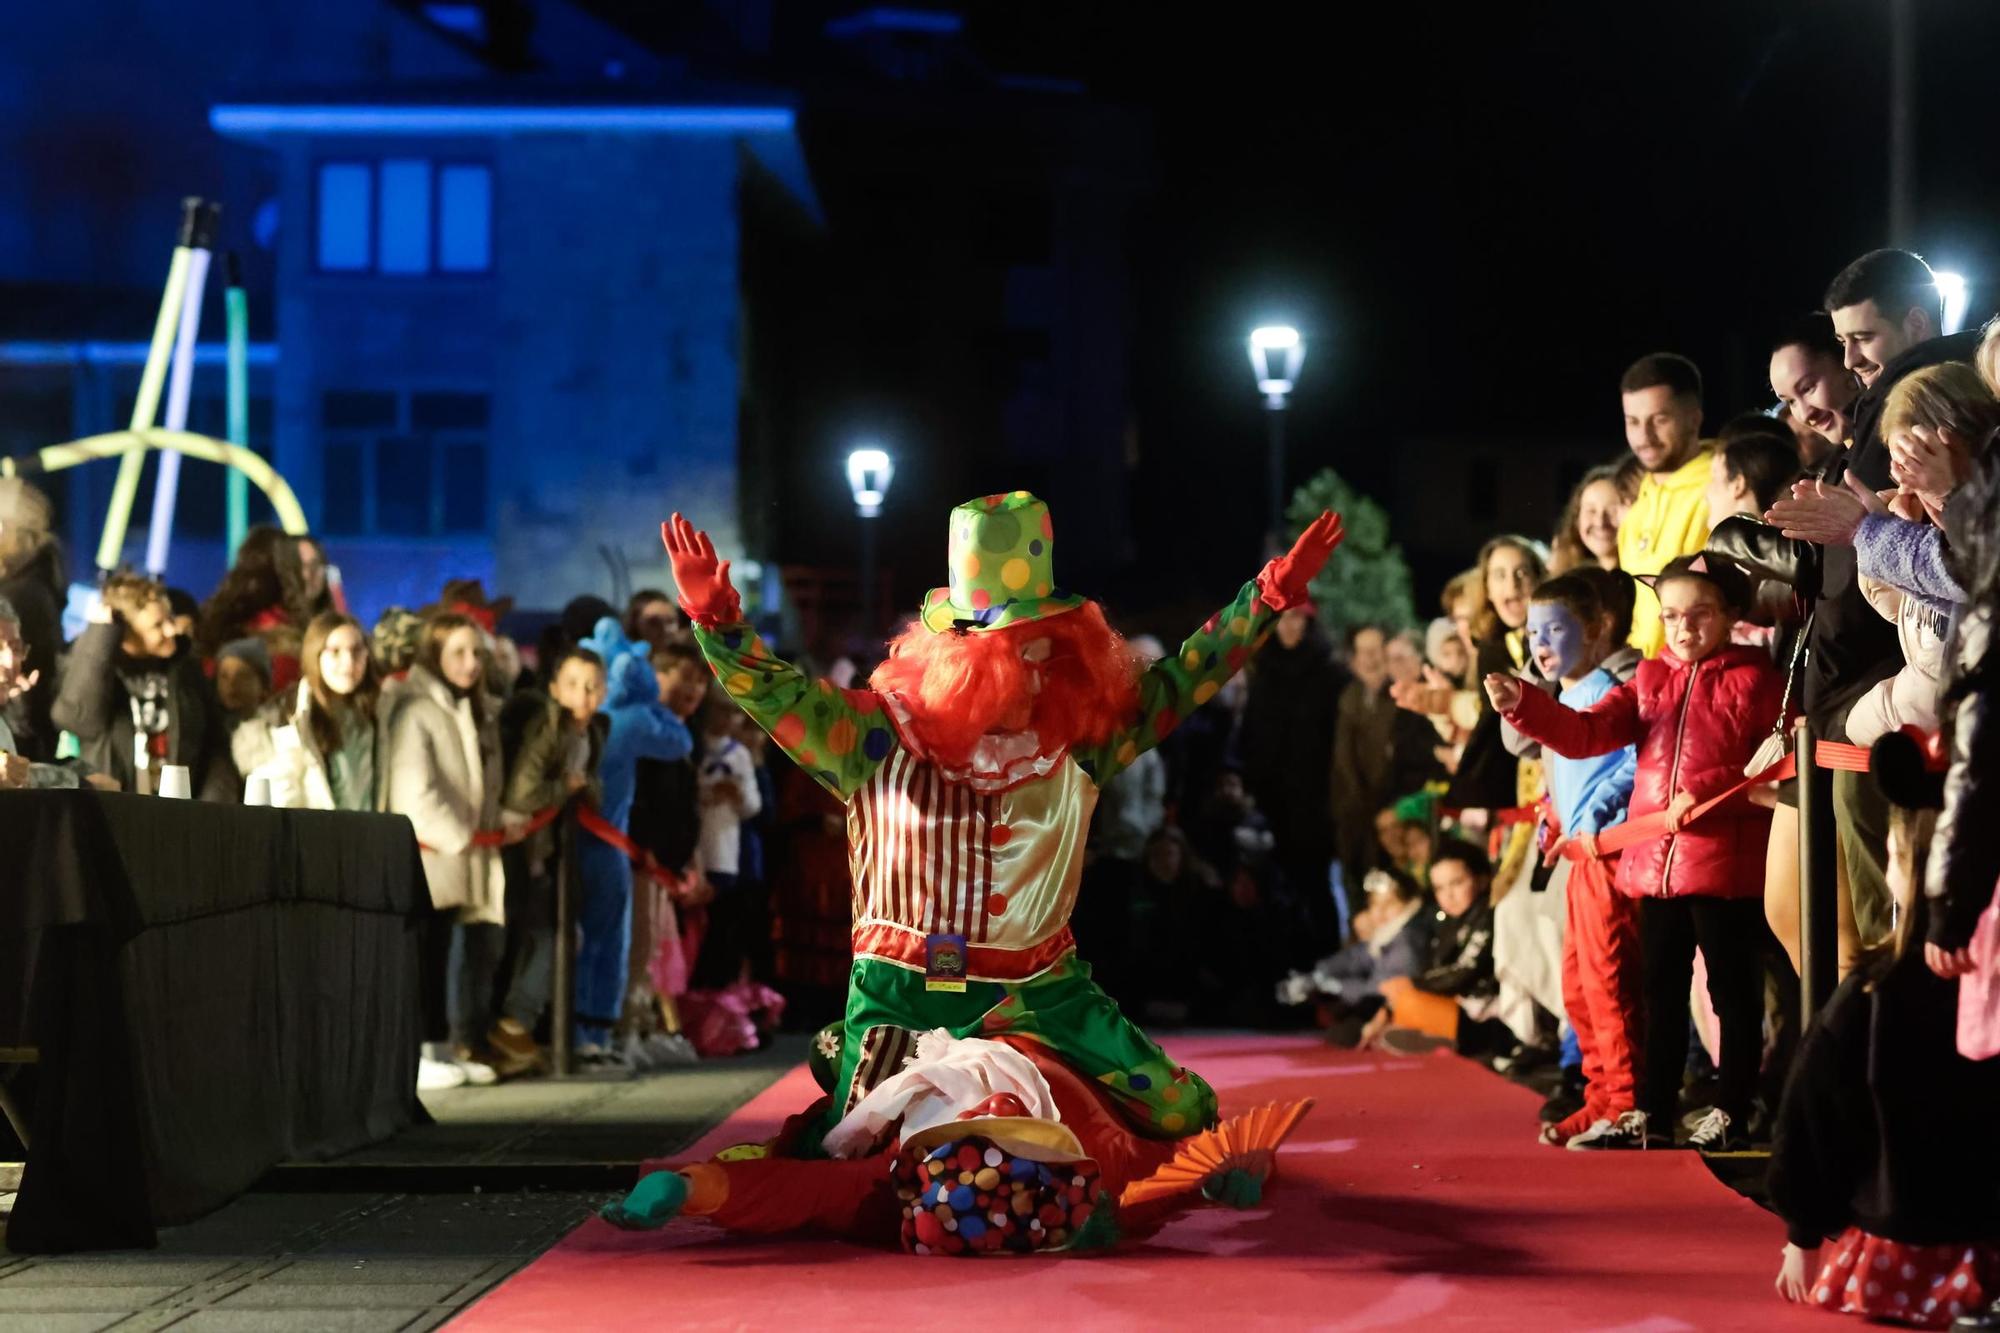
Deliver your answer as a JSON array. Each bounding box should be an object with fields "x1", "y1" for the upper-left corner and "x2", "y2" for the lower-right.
[{"x1": 660, "y1": 514, "x2": 896, "y2": 801}]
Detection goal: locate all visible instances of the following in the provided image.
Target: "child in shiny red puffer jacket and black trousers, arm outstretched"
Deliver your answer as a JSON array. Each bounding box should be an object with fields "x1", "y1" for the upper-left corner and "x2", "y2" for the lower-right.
[{"x1": 1486, "y1": 554, "x2": 1784, "y2": 1151}]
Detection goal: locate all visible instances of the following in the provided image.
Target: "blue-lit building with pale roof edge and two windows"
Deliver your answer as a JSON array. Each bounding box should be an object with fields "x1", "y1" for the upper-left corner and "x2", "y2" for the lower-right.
[{"x1": 210, "y1": 94, "x2": 814, "y2": 606}]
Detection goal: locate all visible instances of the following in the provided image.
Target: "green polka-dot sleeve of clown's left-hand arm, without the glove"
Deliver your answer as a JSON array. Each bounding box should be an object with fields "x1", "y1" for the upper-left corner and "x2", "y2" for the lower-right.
[{"x1": 694, "y1": 624, "x2": 896, "y2": 801}]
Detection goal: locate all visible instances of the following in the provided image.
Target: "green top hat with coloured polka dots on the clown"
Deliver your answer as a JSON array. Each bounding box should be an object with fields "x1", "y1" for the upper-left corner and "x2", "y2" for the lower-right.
[{"x1": 924, "y1": 490, "x2": 1084, "y2": 632}]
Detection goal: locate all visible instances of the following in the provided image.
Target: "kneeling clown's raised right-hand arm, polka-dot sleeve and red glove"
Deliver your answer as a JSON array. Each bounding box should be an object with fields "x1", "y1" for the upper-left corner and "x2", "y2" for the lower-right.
[{"x1": 1076, "y1": 510, "x2": 1344, "y2": 787}]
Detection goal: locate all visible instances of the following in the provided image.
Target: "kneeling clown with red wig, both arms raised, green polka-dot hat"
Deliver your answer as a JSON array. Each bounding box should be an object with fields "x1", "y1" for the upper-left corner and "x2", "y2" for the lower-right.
[{"x1": 664, "y1": 490, "x2": 1342, "y2": 1157}]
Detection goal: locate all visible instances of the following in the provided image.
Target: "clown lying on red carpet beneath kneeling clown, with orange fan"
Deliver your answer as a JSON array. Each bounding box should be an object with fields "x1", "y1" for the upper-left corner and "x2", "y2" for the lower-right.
[{"x1": 602, "y1": 1031, "x2": 1312, "y2": 1257}]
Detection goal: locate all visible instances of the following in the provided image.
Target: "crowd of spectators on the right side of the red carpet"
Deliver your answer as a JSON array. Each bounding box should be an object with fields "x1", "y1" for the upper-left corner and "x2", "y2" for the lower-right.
[{"x1": 1078, "y1": 250, "x2": 2000, "y2": 1327}]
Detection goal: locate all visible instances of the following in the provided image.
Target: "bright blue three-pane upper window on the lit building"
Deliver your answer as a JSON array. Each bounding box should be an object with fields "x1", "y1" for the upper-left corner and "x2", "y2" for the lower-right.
[{"x1": 314, "y1": 158, "x2": 494, "y2": 278}]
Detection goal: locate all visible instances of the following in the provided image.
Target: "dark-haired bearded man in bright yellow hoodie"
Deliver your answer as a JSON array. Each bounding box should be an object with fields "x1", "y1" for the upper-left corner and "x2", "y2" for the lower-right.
[{"x1": 1618, "y1": 352, "x2": 1710, "y2": 656}]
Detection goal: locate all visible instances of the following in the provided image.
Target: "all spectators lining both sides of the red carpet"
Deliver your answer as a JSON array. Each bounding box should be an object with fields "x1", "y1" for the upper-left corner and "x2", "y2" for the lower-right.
[{"x1": 0, "y1": 250, "x2": 2000, "y2": 1323}]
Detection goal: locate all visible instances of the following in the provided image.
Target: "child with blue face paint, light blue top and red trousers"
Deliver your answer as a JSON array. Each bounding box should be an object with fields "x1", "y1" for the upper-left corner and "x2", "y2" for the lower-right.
[{"x1": 1528, "y1": 570, "x2": 1642, "y2": 1147}]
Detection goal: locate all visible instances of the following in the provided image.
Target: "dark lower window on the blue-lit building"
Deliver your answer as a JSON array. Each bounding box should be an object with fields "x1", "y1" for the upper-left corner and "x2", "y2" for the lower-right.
[{"x1": 320, "y1": 390, "x2": 492, "y2": 536}]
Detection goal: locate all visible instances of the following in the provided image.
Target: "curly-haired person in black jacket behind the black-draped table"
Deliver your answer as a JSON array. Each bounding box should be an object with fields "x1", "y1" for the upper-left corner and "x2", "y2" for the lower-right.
[{"x1": 54, "y1": 574, "x2": 240, "y2": 803}]
